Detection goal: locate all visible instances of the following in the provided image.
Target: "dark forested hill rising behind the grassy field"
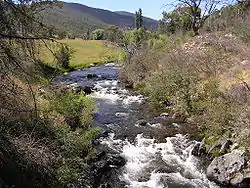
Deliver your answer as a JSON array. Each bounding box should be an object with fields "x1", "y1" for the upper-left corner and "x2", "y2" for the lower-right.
[{"x1": 42, "y1": 2, "x2": 157, "y2": 34}]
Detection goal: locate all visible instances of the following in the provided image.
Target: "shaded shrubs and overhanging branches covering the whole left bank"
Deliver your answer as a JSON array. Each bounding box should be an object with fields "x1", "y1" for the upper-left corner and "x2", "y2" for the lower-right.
[{"x1": 0, "y1": 1, "x2": 102, "y2": 188}]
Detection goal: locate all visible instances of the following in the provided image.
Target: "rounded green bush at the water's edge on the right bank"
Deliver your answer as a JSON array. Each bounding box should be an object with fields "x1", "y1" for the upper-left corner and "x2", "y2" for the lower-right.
[{"x1": 145, "y1": 69, "x2": 199, "y2": 115}]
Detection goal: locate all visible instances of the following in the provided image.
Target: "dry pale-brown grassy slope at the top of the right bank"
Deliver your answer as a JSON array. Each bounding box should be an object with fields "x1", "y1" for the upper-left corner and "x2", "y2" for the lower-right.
[{"x1": 160, "y1": 32, "x2": 250, "y2": 89}]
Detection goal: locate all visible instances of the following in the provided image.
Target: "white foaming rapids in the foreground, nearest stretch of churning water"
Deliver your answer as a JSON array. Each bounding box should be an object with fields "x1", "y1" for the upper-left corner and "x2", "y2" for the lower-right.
[{"x1": 101, "y1": 134, "x2": 217, "y2": 188}]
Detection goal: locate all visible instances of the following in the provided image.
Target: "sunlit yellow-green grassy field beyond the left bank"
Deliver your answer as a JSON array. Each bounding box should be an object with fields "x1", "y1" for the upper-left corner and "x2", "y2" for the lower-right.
[{"x1": 40, "y1": 39, "x2": 120, "y2": 69}]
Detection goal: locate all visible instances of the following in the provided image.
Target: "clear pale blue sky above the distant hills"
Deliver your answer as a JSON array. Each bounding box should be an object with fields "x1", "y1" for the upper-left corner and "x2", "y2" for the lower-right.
[{"x1": 66, "y1": 0, "x2": 170, "y2": 20}]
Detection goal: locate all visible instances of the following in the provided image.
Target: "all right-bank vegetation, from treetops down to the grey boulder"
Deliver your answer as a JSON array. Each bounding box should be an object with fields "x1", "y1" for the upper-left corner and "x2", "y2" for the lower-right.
[{"x1": 120, "y1": 1, "x2": 250, "y2": 187}]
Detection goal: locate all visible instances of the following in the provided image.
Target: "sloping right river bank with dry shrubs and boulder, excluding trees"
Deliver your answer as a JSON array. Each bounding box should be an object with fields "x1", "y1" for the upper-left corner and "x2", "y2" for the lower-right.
[{"x1": 118, "y1": 32, "x2": 250, "y2": 187}]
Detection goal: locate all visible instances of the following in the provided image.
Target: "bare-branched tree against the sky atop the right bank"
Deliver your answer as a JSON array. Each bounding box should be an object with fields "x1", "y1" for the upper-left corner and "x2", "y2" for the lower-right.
[{"x1": 169, "y1": 0, "x2": 228, "y2": 35}]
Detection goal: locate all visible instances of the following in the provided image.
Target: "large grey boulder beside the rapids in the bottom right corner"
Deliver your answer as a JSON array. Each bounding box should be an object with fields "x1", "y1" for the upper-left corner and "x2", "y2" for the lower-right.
[{"x1": 207, "y1": 150, "x2": 246, "y2": 186}]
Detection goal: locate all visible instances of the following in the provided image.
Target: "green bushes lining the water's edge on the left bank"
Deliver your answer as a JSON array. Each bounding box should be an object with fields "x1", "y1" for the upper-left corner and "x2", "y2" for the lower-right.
[{"x1": 41, "y1": 91, "x2": 99, "y2": 187}]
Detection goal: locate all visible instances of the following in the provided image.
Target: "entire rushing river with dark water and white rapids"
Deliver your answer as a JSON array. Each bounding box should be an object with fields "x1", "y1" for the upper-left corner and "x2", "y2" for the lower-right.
[{"x1": 56, "y1": 64, "x2": 217, "y2": 188}]
